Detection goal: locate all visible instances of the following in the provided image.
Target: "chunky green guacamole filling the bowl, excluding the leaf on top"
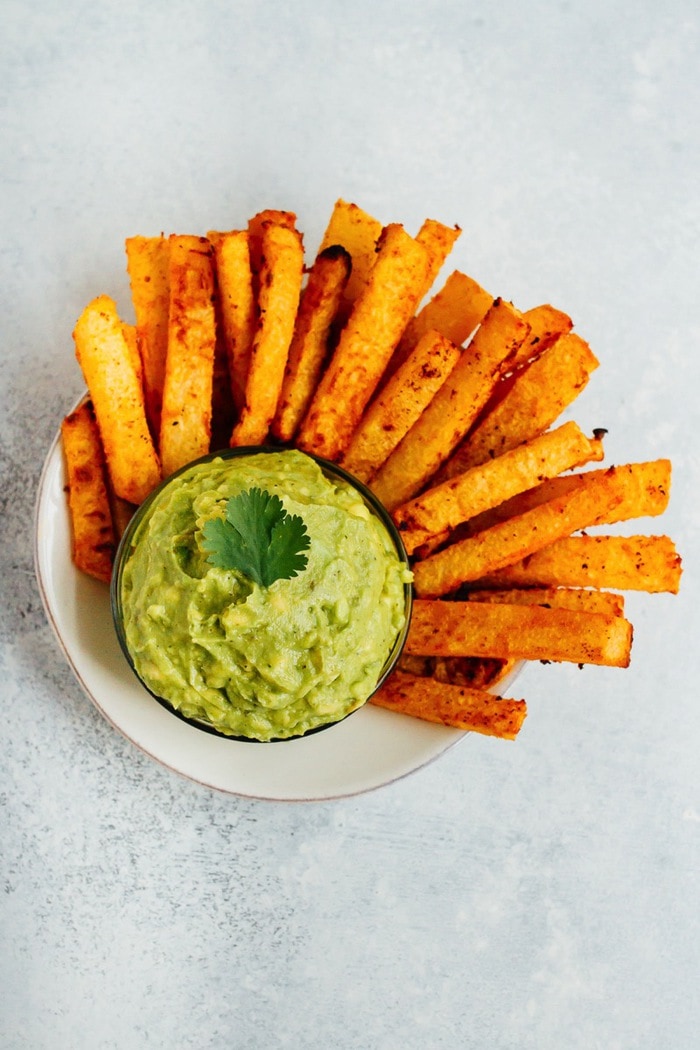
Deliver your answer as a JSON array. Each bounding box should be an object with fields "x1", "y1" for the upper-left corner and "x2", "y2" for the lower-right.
[{"x1": 119, "y1": 450, "x2": 410, "y2": 740}]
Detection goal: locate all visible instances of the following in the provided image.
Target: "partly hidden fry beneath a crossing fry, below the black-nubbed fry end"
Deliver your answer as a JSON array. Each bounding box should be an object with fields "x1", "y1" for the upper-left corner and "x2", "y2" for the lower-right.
[{"x1": 460, "y1": 459, "x2": 671, "y2": 537}]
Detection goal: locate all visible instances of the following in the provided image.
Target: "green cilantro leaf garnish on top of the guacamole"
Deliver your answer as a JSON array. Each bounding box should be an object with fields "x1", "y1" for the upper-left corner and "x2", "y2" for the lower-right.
[{"x1": 203, "y1": 488, "x2": 311, "y2": 587}]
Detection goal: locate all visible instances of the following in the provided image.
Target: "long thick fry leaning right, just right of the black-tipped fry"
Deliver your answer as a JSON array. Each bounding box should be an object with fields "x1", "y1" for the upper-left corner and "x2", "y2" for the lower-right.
[{"x1": 297, "y1": 223, "x2": 428, "y2": 460}]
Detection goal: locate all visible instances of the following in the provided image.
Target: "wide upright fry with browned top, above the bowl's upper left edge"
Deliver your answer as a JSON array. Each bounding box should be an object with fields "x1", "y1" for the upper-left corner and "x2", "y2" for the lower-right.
[{"x1": 161, "y1": 234, "x2": 216, "y2": 478}]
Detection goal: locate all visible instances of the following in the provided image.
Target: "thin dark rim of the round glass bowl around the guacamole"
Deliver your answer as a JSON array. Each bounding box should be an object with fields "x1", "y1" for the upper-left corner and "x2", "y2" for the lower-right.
[{"x1": 110, "y1": 445, "x2": 412, "y2": 743}]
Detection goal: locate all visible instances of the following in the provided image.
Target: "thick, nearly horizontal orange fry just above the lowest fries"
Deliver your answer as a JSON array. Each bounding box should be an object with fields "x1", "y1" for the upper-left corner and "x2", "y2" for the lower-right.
[{"x1": 406, "y1": 599, "x2": 632, "y2": 667}]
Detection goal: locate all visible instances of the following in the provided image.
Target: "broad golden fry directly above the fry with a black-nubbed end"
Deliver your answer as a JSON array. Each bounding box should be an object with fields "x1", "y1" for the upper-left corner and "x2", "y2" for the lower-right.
[{"x1": 439, "y1": 334, "x2": 598, "y2": 481}]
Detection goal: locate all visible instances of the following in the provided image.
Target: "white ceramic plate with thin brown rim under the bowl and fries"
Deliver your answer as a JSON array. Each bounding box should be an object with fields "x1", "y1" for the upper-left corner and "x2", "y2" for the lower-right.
[{"x1": 35, "y1": 426, "x2": 465, "y2": 802}]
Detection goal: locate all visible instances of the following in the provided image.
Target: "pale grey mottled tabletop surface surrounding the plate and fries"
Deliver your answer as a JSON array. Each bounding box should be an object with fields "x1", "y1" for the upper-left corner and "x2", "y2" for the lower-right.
[{"x1": 0, "y1": 0, "x2": 700, "y2": 1050}]
